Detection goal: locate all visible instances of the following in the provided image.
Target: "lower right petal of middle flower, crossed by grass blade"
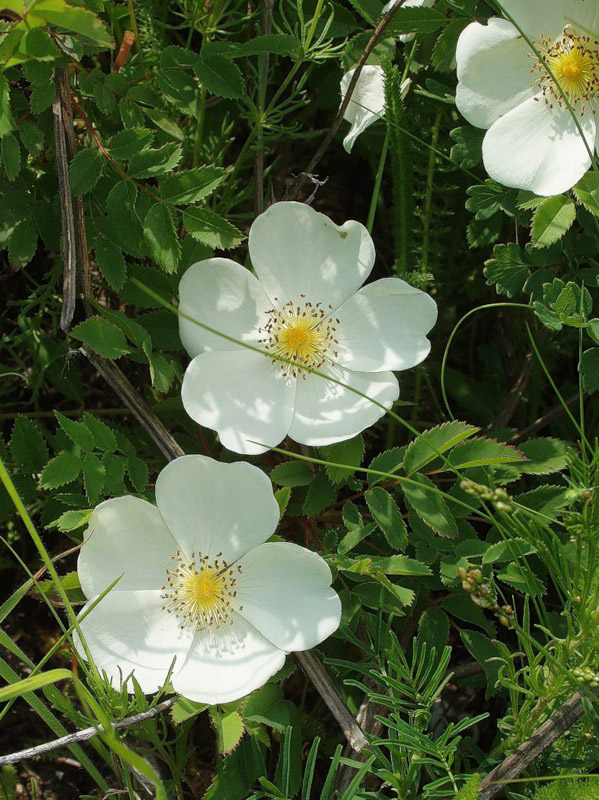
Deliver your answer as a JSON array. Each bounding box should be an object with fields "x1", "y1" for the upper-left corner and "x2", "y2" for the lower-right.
[{"x1": 289, "y1": 366, "x2": 399, "y2": 445}]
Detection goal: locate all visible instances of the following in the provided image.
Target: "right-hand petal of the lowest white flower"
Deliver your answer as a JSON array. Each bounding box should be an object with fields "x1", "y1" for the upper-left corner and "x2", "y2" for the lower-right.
[{"x1": 236, "y1": 542, "x2": 341, "y2": 651}]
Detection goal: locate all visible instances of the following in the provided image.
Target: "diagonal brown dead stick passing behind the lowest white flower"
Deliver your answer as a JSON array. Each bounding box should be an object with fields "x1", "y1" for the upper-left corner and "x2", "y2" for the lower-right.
[{"x1": 82, "y1": 347, "x2": 368, "y2": 752}]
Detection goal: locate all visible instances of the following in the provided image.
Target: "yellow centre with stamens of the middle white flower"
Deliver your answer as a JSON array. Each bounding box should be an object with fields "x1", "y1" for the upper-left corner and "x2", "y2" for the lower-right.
[{"x1": 261, "y1": 295, "x2": 339, "y2": 378}]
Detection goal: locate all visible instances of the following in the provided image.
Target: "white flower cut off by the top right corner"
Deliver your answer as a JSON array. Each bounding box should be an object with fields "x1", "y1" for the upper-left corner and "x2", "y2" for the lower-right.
[{"x1": 456, "y1": 0, "x2": 599, "y2": 195}]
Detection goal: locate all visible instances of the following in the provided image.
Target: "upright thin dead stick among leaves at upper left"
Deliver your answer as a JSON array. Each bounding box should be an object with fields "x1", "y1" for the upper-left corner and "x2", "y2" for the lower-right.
[{"x1": 52, "y1": 67, "x2": 77, "y2": 332}]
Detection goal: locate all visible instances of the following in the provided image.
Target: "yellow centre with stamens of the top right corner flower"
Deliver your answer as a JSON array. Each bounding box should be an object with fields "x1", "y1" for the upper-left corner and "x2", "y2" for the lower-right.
[{"x1": 533, "y1": 27, "x2": 599, "y2": 113}]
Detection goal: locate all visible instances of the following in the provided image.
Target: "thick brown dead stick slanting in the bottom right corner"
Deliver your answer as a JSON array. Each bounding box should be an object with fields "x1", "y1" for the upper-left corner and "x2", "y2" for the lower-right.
[{"x1": 478, "y1": 692, "x2": 584, "y2": 800}]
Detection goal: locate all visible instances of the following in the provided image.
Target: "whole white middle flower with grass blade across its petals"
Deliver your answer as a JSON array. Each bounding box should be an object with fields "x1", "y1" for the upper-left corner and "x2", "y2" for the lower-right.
[{"x1": 179, "y1": 202, "x2": 437, "y2": 454}]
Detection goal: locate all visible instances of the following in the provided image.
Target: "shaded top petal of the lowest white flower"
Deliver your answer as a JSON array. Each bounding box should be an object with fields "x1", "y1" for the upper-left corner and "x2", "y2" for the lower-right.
[{"x1": 158, "y1": 455, "x2": 279, "y2": 563}]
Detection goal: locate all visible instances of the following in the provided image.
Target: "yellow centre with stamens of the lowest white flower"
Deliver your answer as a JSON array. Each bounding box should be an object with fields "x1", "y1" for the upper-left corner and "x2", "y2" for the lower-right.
[{"x1": 161, "y1": 551, "x2": 242, "y2": 630}]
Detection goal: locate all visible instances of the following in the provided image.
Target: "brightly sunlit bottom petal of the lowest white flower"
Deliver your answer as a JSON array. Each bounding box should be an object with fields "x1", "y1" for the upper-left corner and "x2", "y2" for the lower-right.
[{"x1": 172, "y1": 614, "x2": 285, "y2": 705}]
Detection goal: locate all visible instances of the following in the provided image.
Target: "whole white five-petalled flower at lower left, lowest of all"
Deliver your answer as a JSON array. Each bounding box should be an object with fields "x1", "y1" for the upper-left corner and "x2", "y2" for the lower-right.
[{"x1": 76, "y1": 456, "x2": 341, "y2": 704}]
